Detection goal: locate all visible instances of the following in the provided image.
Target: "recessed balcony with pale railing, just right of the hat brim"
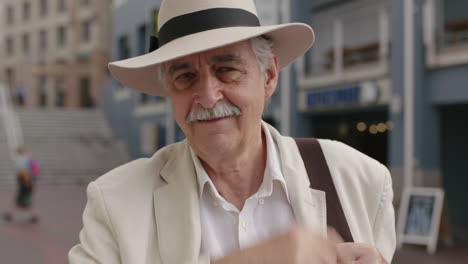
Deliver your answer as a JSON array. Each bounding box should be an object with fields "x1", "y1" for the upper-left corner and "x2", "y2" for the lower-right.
[{"x1": 298, "y1": 1, "x2": 390, "y2": 89}]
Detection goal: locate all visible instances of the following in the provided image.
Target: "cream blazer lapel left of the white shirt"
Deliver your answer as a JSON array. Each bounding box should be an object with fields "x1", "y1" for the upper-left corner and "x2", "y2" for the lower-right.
[{"x1": 153, "y1": 142, "x2": 201, "y2": 264}]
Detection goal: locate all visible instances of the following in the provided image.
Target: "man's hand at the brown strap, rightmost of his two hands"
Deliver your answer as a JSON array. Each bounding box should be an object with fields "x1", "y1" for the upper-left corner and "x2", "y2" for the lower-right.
[{"x1": 336, "y1": 243, "x2": 387, "y2": 264}]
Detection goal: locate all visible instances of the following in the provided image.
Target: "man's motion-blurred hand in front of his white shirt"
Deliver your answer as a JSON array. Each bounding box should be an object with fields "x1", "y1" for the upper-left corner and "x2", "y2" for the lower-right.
[{"x1": 213, "y1": 226, "x2": 342, "y2": 264}]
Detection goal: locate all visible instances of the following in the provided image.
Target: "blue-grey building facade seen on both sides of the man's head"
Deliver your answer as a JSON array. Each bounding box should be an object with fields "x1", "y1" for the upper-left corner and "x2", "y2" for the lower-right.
[{"x1": 102, "y1": 0, "x2": 468, "y2": 242}]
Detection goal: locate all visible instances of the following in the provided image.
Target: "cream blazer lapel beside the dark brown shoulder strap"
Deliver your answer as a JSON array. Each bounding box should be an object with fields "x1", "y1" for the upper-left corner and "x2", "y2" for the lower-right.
[{"x1": 269, "y1": 127, "x2": 327, "y2": 236}]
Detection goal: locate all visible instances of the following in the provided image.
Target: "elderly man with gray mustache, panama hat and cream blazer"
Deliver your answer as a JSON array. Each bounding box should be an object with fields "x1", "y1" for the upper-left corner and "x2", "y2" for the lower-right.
[{"x1": 69, "y1": 0, "x2": 395, "y2": 264}]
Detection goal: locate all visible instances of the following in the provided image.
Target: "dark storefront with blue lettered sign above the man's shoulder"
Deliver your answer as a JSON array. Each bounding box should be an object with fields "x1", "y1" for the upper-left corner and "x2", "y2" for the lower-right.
[{"x1": 300, "y1": 79, "x2": 393, "y2": 164}]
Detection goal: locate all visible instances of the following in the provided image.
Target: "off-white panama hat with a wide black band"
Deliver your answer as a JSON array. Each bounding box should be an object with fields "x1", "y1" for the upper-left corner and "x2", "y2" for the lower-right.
[{"x1": 109, "y1": 0, "x2": 315, "y2": 97}]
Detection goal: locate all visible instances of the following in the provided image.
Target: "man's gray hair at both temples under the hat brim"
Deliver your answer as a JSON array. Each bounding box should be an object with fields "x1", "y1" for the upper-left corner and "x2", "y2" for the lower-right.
[{"x1": 156, "y1": 36, "x2": 273, "y2": 89}]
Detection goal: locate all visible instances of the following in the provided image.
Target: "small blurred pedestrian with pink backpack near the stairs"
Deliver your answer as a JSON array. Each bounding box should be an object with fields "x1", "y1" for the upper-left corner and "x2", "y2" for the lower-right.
[{"x1": 3, "y1": 146, "x2": 39, "y2": 224}]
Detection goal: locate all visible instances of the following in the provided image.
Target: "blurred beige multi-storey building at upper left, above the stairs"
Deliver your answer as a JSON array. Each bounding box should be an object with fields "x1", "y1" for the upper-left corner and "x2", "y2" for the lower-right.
[{"x1": 0, "y1": 0, "x2": 111, "y2": 108}]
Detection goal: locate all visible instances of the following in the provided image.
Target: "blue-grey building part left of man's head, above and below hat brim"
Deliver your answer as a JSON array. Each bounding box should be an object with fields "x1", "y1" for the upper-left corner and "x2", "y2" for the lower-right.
[{"x1": 101, "y1": 0, "x2": 169, "y2": 158}]
